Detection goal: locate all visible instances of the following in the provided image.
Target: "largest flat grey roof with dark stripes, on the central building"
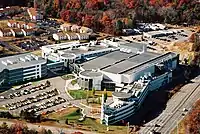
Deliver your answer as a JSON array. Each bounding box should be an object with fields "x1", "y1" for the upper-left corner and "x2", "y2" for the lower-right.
[{"x1": 81, "y1": 51, "x2": 176, "y2": 74}]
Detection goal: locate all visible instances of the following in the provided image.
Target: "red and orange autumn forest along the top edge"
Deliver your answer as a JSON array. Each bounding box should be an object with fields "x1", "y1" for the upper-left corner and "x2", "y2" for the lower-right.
[{"x1": 31, "y1": 0, "x2": 200, "y2": 35}]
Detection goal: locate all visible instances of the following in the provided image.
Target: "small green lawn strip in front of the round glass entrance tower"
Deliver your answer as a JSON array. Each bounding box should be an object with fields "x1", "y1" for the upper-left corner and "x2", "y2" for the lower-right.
[{"x1": 69, "y1": 90, "x2": 112, "y2": 99}]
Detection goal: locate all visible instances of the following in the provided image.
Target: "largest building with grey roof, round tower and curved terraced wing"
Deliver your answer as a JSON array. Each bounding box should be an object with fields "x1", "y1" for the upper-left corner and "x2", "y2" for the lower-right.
[{"x1": 71, "y1": 39, "x2": 179, "y2": 125}]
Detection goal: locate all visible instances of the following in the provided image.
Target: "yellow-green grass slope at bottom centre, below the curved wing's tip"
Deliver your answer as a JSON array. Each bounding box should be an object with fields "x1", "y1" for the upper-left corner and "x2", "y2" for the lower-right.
[{"x1": 48, "y1": 107, "x2": 126, "y2": 134}]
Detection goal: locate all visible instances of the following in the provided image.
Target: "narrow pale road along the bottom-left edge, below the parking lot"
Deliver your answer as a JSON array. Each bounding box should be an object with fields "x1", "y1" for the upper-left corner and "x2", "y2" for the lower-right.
[{"x1": 0, "y1": 121, "x2": 96, "y2": 134}]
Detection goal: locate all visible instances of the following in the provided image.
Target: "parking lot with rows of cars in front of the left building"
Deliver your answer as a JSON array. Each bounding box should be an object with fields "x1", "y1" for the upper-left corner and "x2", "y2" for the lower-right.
[{"x1": 0, "y1": 77, "x2": 69, "y2": 114}]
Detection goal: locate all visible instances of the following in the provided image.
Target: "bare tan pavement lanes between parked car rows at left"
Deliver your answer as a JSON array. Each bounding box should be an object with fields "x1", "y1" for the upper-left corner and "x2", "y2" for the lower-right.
[{"x1": 0, "y1": 77, "x2": 71, "y2": 114}]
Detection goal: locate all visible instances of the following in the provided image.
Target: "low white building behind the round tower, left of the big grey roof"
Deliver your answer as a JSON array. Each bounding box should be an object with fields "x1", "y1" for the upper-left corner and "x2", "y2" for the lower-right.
[{"x1": 41, "y1": 41, "x2": 119, "y2": 61}]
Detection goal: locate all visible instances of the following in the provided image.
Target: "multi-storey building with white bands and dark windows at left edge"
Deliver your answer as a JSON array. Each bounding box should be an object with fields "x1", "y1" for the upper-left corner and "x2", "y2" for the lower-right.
[{"x1": 0, "y1": 53, "x2": 47, "y2": 85}]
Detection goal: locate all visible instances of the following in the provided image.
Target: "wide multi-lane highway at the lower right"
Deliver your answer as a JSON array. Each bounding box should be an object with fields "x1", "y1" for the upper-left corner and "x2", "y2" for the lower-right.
[{"x1": 139, "y1": 78, "x2": 200, "y2": 134}]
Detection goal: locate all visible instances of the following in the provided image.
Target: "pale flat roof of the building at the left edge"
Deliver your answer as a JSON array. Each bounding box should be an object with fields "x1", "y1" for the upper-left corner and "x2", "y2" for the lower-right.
[{"x1": 0, "y1": 53, "x2": 46, "y2": 71}]
